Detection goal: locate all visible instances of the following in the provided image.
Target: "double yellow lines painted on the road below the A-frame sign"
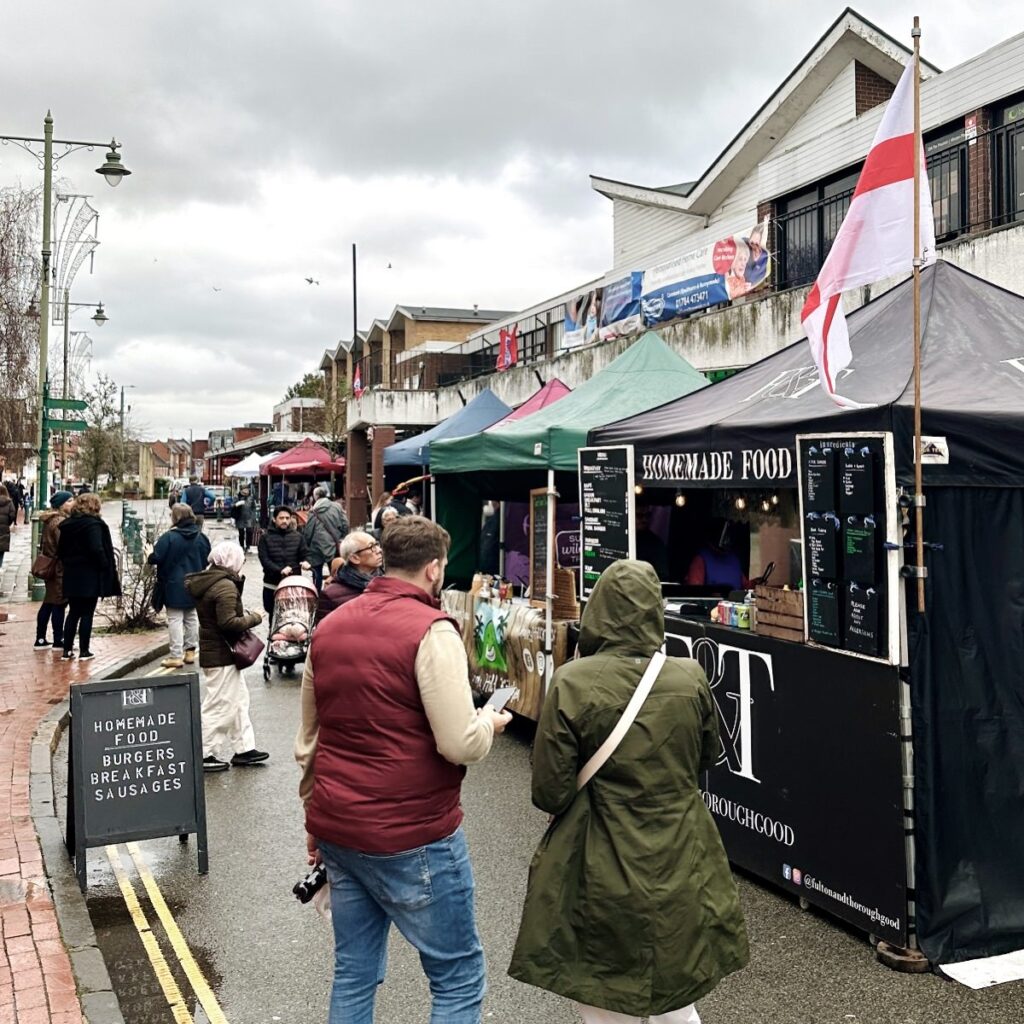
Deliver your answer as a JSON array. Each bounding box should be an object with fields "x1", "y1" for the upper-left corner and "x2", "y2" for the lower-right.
[{"x1": 106, "y1": 843, "x2": 227, "y2": 1024}]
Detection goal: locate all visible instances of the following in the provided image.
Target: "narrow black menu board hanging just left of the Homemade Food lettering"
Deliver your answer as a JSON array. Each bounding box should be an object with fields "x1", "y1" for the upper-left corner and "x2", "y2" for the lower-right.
[{"x1": 579, "y1": 445, "x2": 636, "y2": 601}]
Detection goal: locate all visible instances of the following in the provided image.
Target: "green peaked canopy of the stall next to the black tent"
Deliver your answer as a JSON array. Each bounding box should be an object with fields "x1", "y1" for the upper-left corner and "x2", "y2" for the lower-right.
[{"x1": 430, "y1": 332, "x2": 708, "y2": 589}]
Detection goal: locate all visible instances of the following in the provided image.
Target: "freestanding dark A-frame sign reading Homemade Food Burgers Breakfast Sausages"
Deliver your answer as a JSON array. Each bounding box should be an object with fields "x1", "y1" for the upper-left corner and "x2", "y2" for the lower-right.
[{"x1": 67, "y1": 673, "x2": 208, "y2": 892}]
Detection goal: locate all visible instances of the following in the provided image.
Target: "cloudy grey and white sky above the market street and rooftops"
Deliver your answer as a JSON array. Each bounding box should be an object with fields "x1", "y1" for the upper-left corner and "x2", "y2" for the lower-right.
[{"x1": 0, "y1": 0, "x2": 1024, "y2": 436}]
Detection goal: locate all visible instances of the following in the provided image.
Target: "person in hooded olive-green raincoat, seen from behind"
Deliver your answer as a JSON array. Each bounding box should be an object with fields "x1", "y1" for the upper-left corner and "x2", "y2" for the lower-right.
[{"x1": 509, "y1": 560, "x2": 750, "y2": 1024}]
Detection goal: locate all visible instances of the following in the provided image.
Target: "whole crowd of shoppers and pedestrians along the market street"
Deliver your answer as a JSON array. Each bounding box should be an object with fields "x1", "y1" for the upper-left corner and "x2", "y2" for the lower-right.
[{"x1": 16, "y1": 479, "x2": 749, "y2": 1024}]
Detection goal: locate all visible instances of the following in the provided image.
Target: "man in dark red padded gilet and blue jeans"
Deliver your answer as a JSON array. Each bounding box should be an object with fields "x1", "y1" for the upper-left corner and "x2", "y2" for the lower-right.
[{"x1": 295, "y1": 516, "x2": 512, "y2": 1024}]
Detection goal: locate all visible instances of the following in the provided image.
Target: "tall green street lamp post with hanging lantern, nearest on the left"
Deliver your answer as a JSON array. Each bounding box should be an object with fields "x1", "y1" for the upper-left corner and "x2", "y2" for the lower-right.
[{"x1": 0, "y1": 111, "x2": 131, "y2": 565}]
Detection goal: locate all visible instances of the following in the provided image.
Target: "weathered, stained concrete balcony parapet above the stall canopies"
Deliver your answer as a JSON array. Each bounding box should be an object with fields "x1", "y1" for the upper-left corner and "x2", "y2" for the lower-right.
[{"x1": 348, "y1": 224, "x2": 1024, "y2": 427}]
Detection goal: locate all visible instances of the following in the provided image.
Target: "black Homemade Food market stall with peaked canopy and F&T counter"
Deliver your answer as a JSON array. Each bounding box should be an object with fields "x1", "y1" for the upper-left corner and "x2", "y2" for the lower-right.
[{"x1": 590, "y1": 262, "x2": 1024, "y2": 963}]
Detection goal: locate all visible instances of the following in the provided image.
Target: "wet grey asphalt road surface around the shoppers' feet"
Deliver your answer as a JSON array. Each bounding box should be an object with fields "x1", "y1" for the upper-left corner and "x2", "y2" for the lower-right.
[{"x1": 55, "y1": 530, "x2": 1024, "y2": 1024}]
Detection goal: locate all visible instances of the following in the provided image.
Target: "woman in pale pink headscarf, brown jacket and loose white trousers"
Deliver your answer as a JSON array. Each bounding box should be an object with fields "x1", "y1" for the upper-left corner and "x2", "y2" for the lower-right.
[{"x1": 184, "y1": 541, "x2": 270, "y2": 772}]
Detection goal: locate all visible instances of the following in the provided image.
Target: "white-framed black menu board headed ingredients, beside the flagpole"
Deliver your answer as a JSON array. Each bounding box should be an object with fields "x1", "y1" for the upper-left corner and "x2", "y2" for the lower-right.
[{"x1": 797, "y1": 433, "x2": 898, "y2": 660}]
